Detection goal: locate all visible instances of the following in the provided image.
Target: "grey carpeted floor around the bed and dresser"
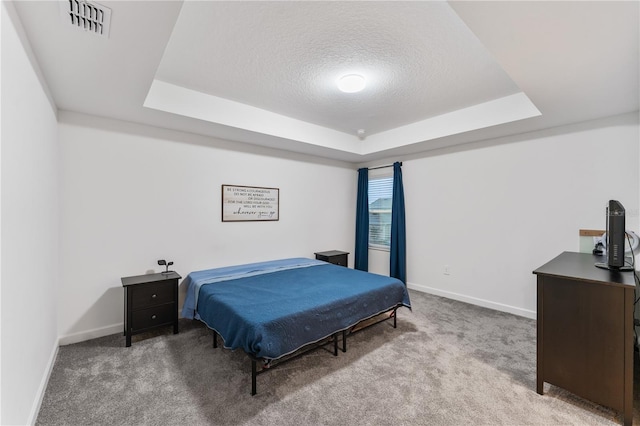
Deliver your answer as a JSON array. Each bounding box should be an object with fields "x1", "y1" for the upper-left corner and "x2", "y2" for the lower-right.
[{"x1": 37, "y1": 291, "x2": 639, "y2": 425}]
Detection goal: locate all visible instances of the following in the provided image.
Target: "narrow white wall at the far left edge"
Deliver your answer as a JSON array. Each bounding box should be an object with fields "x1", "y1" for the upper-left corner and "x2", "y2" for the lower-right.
[{"x1": 0, "y1": 2, "x2": 59, "y2": 425}]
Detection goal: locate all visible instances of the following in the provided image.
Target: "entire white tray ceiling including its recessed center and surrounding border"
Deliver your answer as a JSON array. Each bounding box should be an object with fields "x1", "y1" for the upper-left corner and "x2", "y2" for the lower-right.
[{"x1": 10, "y1": 1, "x2": 640, "y2": 164}]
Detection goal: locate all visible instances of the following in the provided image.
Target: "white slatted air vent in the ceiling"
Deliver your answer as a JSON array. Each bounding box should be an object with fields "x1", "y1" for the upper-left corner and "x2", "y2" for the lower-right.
[{"x1": 59, "y1": 0, "x2": 111, "y2": 38}]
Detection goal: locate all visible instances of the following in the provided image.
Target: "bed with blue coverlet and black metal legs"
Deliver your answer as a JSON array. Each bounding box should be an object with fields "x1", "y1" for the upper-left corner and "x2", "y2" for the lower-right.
[{"x1": 182, "y1": 258, "x2": 411, "y2": 395}]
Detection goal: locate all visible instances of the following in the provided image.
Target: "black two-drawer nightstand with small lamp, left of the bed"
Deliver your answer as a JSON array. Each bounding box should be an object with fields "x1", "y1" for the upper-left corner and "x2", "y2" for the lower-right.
[{"x1": 121, "y1": 271, "x2": 182, "y2": 347}]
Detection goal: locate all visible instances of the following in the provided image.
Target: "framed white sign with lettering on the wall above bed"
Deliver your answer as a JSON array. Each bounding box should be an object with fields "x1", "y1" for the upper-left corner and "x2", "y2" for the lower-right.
[{"x1": 222, "y1": 185, "x2": 280, "y2": 222}]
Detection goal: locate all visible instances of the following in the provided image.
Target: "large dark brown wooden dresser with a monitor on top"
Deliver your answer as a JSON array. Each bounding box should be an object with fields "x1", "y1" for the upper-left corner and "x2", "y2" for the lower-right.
[{"x1": 533, "y1": 252, "x2": 635, "y2": 426}]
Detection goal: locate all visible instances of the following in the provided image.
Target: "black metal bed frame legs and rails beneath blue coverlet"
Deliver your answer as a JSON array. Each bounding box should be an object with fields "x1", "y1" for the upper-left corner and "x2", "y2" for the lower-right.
[{"x1": 212, "y1": 303, "x2": 403, "y2": 396}]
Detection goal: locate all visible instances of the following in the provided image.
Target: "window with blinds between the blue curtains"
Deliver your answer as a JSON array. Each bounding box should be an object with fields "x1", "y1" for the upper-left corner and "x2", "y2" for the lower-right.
[{"x1": 369, "y1": 176, "x2": 393, "y2": 249}]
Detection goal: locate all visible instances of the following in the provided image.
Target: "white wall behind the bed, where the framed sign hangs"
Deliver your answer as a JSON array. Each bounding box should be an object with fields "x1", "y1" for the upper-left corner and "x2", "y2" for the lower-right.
[{"x1": 58, "y1": 112, "x2": 356, "y2": 343}]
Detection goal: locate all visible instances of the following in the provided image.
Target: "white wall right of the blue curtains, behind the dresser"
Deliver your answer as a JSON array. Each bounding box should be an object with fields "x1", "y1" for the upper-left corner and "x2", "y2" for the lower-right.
[{"x1": 370, "y1": 113, "x2": 640, "y2": 318}]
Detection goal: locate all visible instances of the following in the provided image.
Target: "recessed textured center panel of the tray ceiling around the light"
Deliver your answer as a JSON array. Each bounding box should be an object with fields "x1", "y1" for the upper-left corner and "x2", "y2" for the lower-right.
[{"x1": 156, "y1": 2, "x2": 519, "y2": 135}]
